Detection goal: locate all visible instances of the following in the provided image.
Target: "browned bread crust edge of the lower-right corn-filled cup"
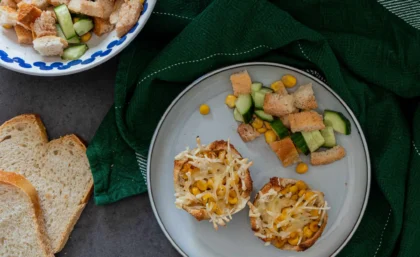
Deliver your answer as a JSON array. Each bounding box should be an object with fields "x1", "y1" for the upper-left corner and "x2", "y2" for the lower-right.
[{"x1": 250, "y1": 177, "x2": 328, "y2": 252}]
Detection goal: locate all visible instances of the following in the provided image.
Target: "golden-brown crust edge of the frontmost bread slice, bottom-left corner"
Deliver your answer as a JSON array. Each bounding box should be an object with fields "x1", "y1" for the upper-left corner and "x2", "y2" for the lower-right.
[{"x1": 0, "y1": 170, "x2": 54, "y2": 257}]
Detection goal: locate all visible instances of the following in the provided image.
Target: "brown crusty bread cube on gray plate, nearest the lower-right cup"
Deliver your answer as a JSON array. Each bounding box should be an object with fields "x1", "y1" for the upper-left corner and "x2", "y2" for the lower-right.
[{"x1": 270, "y1": 137, "x2": 300, "y2": 167}]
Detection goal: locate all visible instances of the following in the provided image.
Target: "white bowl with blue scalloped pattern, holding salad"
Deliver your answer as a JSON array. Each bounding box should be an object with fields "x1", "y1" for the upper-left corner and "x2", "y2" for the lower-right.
[{"x1": 0, "y1": 0, "x2": 156, "y2": 76}]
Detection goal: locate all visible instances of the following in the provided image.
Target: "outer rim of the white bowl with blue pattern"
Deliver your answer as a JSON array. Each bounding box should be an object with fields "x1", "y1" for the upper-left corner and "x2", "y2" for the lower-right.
[{"x1": 0, "y1": 0, "x2": 157, "y2": 77}]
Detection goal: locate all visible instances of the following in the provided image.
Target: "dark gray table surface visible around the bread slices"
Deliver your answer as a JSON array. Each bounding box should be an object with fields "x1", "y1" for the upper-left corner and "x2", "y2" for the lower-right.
[{"x1": 0, "y1": 58, "x2": 179, "y2": 257}]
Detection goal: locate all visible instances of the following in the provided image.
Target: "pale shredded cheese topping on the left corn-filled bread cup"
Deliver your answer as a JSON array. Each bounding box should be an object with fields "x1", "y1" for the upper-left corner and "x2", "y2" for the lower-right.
[{"x1": 175, "y1": 137, "x2": 252, "y2": 229}]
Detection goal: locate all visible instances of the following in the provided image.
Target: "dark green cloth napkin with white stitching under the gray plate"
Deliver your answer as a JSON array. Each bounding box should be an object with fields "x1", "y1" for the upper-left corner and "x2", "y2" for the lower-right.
[{"x1": 88, "y1": 0, "x2": 420, "y2": 254}]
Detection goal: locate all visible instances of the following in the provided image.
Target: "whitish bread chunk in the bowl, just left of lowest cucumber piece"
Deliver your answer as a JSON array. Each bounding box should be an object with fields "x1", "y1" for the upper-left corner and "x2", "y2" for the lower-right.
[{"x1": 33, "y1": 36, "x2": 68, "y2": 56}]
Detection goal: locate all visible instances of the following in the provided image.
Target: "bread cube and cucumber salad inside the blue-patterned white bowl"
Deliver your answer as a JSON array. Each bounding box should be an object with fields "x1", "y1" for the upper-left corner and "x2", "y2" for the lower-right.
[{"x1": 0, "y1": 0, "x2": 144, "y2": 60}]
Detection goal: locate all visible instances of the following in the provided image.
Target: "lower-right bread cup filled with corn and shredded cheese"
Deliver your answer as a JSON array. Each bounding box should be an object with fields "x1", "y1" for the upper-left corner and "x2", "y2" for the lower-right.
[{"x1": 248, "y1": 177, "x2": 330, "y2": 251}]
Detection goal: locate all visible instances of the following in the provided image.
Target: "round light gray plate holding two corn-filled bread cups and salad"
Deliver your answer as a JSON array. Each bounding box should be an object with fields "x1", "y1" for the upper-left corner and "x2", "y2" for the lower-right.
[{"x1": 147, "y1": 63, "x2": 370, "y2": 257}]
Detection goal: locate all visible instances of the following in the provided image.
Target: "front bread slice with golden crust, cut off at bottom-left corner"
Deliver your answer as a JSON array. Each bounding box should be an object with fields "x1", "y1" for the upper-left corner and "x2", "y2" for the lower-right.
[{"x1": 0, "y1": 171, "x2": 54, "y2": 257}]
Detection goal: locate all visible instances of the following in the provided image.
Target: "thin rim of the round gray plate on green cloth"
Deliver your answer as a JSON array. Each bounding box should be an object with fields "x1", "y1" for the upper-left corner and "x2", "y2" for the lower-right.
[{"x1": 147, "y1": 62, "x2": 371, "y2": 257}]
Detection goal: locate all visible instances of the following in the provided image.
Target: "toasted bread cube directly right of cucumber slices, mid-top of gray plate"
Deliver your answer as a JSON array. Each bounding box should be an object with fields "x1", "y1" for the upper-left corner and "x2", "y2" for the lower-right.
[{"x1": 263, "y1": 93, "x2": 296, "y2": 117}]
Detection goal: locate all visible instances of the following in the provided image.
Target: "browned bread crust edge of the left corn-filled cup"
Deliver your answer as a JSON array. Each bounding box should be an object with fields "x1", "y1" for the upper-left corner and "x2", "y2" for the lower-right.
[{"x1": 173, "y1": 140, "x2": 252, "y2": 221}]
